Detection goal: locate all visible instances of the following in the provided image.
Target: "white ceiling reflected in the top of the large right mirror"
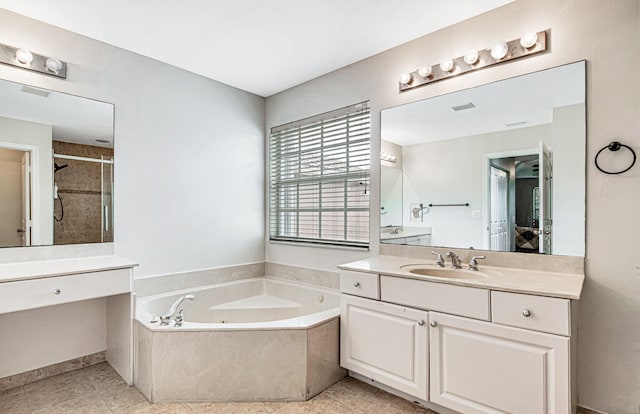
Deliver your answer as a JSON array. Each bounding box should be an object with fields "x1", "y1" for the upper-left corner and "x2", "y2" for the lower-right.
[{"x1": 381, "y1": 62, "x2": 585, "y2": 146}]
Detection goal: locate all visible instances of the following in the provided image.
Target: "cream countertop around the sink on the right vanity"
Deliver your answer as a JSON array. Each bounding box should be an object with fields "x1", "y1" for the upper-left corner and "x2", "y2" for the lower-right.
[{"x1": 338, "y1": 256, "x2": 584, "y2": 299}]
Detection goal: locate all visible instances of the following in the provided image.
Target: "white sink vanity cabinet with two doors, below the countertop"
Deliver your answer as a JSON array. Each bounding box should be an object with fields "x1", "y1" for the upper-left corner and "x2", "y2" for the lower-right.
[{"x1": 340, "y1": 270, "x2": 573, "y2": 414}]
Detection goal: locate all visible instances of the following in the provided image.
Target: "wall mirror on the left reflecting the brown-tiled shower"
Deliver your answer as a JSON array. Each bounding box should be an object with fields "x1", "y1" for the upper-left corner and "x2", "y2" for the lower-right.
[{"x1": 0, "y1": 80, "x2": 114, "y2": 247}]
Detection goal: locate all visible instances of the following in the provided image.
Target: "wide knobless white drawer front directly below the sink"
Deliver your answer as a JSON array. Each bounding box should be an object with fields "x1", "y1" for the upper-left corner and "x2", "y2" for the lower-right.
[{"x1": 380, "y1": 276, "x2": 490, "y2": 321}]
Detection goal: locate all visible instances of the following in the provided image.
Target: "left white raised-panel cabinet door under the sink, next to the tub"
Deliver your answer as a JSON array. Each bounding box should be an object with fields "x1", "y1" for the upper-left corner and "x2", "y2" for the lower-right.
[{"x1": 340, "y1": 295, "x2": 428, "y2": 400}]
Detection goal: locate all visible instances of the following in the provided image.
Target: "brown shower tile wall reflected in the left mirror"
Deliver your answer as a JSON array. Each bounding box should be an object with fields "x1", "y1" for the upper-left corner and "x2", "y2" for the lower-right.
[{"x1": 53, "y1": 141, "x2": 113, "y2": 244}]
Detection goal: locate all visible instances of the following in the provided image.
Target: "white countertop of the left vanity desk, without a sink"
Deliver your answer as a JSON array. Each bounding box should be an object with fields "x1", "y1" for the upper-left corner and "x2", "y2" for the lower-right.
[{"x1": 0, "y1": 256, "x2": 138, "y2": 283}]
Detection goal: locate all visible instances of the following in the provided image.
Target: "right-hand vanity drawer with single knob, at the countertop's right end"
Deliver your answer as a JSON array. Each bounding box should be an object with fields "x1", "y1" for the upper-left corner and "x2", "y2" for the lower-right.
[{"x1": 491, "y1": 292, "x2": 571, "y2": 336}]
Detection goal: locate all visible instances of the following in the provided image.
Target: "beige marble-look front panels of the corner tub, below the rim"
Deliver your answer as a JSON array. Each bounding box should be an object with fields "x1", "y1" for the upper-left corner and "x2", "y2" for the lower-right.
[{"x1": 134, "y1": 318, "x2": 345, "y2": 403}]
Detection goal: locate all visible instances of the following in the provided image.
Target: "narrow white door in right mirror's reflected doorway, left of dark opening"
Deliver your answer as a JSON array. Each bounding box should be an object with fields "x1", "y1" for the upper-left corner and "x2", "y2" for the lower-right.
[{"x1": 489, "y1": 165, "x2": 510, "y2": 252}]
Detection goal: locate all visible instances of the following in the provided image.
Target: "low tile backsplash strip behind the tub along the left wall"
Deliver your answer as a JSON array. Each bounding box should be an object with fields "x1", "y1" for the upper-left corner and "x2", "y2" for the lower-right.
[{"x1": 133, "y1": 262, "x2": 265, "y2": 297}]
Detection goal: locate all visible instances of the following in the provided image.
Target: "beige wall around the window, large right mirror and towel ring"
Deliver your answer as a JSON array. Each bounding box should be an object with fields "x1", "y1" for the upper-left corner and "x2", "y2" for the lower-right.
[{"x1": 266, "y1": 0, "x2": 640, "y2": 414}]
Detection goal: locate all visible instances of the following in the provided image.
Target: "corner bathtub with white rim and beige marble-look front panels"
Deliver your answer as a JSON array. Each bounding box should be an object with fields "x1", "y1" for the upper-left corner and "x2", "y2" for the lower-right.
[{"x1": 134, "y1": 277, "x2": 345, "y2": 403}]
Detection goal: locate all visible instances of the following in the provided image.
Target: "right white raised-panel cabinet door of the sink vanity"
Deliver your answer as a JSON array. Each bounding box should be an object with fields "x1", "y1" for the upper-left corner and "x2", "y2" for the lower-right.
[{"x1": 429, "y1": 312, "x2": 571, "y2": 414}]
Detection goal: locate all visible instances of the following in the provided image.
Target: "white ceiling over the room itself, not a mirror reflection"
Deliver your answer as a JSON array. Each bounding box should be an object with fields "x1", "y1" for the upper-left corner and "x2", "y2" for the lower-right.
[{"x1": 0, "y1": 0, "x2": 513, "y2": 96}]
